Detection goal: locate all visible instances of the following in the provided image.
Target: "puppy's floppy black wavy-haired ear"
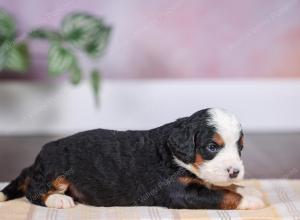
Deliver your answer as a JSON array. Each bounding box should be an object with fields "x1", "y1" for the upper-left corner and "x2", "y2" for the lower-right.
[{"x1": 168, "y1": 124, "x2": 196, "y2": 163}]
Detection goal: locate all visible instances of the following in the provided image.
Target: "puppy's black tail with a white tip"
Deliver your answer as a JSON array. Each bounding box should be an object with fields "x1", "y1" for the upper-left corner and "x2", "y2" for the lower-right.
[{"x1": 0, "y1": 167, "x2": 31, "y2": 202}]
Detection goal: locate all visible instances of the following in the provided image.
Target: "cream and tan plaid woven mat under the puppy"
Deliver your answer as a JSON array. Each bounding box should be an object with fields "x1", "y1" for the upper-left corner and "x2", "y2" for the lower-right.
[{"x1": 0, "y1": 179, "x2": 300, "y2": 220}]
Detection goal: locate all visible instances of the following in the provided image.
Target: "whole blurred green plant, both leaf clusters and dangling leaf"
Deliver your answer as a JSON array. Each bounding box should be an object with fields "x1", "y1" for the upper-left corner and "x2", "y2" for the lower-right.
[{"x1": 0, "y1": 9, "x2": 111, "y2": 104}]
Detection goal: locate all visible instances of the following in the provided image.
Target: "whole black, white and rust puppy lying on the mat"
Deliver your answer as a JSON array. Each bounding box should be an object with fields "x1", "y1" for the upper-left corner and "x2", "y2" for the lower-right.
[{"x1": 0, "y1": 108, "x2": 264, "y2": 209}]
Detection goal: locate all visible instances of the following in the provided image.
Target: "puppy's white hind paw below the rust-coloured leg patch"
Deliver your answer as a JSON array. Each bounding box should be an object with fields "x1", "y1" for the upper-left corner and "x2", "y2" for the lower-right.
[{"x1": 45, "y1": 194, "x2": 75, "y2": 209}]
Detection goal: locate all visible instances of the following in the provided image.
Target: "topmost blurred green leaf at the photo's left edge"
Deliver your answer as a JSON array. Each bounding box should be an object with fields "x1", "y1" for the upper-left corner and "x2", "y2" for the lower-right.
[{"x1": 0, "y1": 9, "x2": 16, "y2": 39}]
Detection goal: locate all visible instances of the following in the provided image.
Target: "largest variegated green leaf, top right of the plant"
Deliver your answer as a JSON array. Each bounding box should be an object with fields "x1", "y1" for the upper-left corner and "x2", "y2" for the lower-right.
[{"x1": 61, "y1": 13, "x2": 111, "y2": 57}]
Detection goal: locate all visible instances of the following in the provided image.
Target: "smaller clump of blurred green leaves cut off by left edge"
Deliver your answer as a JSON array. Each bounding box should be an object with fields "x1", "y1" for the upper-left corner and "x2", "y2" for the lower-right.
[{"x1": 0, "y1": 10, "x2": 30, "y2": 73}]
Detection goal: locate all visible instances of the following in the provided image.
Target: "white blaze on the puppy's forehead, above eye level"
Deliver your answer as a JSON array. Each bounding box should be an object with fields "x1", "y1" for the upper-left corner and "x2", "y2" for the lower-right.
[{"x1": 208, "y1": 108, "x2": 242, "y2": 144}]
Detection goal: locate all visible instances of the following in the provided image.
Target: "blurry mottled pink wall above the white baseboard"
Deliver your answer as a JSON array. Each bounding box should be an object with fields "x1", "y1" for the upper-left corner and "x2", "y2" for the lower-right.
[{"x1": 0, "y1": 0, "x2": 300, "y2": 78}]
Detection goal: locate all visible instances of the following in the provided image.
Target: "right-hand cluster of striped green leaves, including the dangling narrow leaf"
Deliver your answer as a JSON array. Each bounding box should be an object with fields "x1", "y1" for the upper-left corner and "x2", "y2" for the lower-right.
[{"x1": 29, "y1": 12, "x2": 111, "y2": 102}]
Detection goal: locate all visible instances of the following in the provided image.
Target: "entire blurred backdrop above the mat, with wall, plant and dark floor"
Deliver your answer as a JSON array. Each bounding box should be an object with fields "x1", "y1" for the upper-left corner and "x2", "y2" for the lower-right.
[{"x1": 0, "y1": 0, "x2": 300, "y2": 181}]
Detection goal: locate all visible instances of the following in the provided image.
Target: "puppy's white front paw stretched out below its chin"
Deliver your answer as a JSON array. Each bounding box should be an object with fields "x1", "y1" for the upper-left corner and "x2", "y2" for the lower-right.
[{"x1": 237, "y1": 187, "x2": 266, "y2": 209}]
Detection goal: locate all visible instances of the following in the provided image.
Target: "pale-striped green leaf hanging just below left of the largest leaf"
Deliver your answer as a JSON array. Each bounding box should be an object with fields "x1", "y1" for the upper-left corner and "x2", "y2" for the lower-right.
[{"x1": 48, "y1": 44, "x2": 76, "y2": 75}]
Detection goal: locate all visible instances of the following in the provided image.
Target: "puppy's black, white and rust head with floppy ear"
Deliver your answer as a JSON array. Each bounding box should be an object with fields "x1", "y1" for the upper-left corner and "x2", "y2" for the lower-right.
[{"x1": 168, "y1": 108, "x2": 244, "y2": 186}]
